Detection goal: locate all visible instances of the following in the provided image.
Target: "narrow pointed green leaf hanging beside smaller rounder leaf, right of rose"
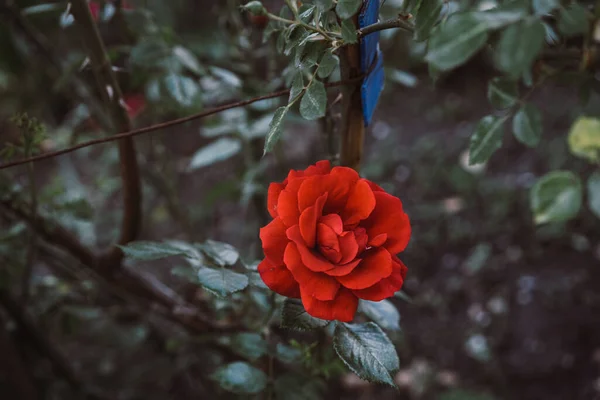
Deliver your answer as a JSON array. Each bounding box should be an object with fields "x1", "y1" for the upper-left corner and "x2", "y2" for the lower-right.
[{"x1": 469, "y1": 115, "x2": 506, "y2": 165}]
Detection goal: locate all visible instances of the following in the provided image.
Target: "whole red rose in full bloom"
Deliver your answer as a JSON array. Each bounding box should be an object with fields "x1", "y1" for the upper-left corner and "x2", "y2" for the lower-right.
[{"x1": 258, "y1": 161, "x2": 411, "y2": 322}]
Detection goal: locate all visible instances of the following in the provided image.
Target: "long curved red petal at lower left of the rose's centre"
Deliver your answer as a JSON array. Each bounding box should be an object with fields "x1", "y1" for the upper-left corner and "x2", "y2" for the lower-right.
[{"x1": 283, "y1": 242, "x2": 340, "y2": 300}]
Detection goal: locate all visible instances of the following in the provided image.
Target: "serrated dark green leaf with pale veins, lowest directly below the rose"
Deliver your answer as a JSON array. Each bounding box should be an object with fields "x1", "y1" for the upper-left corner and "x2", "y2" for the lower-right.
[{"x1": 333, "y1": 322, "x2": 400, "y2": 386}]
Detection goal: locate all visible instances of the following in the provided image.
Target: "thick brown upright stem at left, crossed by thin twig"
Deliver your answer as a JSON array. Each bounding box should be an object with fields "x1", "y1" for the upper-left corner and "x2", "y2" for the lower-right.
[{"x1": 71, "y1": 0, "x2": 142, "y2": 271}]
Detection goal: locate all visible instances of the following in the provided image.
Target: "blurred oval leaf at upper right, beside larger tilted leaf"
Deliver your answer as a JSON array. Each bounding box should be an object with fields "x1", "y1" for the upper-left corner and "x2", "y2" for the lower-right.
[{"x1": 495, "y1": 19, "x2": 546, "y2": 78}]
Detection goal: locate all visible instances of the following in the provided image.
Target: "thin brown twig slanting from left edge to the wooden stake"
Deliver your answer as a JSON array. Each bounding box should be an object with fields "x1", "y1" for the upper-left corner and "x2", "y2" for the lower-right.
[{"x1": 0, "y1": 76, "x2": 362, "y2": 170}]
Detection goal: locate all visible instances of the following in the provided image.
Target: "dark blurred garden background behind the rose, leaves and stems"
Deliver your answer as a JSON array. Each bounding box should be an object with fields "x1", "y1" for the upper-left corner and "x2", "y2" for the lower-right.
[{"x1": 0, "y1": 0, "x2": 600, "y2": 400}]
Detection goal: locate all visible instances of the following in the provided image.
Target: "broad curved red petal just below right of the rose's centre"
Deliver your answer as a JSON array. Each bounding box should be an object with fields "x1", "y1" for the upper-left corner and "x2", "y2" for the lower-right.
[{"x1": 337, "y1": 247, "x2": 392, "y2": 289}]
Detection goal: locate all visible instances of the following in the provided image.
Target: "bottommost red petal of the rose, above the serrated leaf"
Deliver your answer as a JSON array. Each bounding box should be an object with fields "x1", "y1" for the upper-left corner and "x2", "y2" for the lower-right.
[{"x1": 300, "y1": 287, "x2": 358, "y2": 322}]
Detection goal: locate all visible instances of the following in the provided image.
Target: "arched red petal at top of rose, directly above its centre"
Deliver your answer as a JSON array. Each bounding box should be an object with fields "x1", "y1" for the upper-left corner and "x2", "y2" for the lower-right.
[{"x1": 298, "y1": 167, "x2": 358, "y2": 214}]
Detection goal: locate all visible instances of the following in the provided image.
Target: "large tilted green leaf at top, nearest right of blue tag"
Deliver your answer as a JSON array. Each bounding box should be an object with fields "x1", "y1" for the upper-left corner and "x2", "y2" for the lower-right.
[{"x1": 425, "y1": 13, "x2": 488, "y2": 71}]
